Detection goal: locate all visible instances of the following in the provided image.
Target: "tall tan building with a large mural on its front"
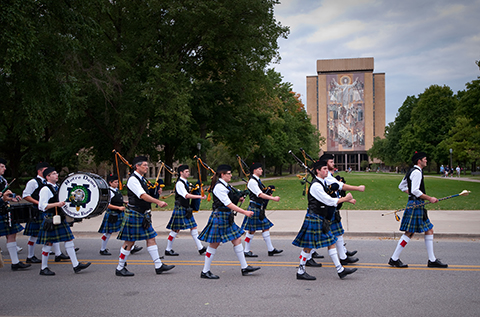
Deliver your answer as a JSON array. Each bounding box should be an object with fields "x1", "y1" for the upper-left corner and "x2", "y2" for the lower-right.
[{"x1": 307, "y1": 57, "x2": 385, "y2": 170}]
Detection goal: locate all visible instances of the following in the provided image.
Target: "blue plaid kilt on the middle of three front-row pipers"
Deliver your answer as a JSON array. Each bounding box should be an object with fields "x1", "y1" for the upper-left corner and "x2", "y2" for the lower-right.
[{"x1": 198, "y1": 211, "x2": 245, "y2": 243}]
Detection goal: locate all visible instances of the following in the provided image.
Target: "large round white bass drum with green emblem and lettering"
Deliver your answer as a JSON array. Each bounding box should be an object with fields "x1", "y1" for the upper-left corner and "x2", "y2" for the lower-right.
[{"x1": 58, "y1": 172, "x2": 110, "y2": 219}]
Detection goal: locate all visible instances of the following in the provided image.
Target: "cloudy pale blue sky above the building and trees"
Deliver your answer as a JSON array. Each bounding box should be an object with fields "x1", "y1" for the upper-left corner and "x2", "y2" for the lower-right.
[{"x1": 271, "y1": 0, "x2": 480, "y2": 124}]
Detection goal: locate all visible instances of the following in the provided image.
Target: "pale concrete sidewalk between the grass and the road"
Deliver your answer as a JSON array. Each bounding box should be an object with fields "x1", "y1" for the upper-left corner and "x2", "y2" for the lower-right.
[{"x1": 72, "y1": 210, "x2": 480, "y2": 239}]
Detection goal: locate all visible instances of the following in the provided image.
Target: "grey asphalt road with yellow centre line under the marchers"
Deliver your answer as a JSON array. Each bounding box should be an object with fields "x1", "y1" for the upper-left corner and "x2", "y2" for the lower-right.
[{"x1": 0, "y1": 234, "x2": 480, "y2": 317}]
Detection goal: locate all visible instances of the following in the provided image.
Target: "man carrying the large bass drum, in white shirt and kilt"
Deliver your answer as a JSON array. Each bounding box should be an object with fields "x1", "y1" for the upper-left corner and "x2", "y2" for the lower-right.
[{"x1": 37, "y1": 167, "x2": 91, "y2": 276}]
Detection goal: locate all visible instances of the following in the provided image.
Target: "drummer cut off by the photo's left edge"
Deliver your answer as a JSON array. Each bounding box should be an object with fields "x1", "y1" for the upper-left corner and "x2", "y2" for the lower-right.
[{"x1": 0, "y1": 158, "x2": 31, "y2": 271}]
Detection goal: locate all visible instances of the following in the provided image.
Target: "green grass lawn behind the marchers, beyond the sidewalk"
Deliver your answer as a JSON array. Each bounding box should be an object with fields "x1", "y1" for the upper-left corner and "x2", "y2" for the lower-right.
[{"x1": 156, "y1": 172, "x2": 480, "y2": 210}]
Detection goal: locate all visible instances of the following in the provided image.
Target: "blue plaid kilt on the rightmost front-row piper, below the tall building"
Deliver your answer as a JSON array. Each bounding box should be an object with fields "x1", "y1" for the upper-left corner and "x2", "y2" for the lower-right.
[{"x1": 292, "y1": 211, "x2": 337, "y2": 249}]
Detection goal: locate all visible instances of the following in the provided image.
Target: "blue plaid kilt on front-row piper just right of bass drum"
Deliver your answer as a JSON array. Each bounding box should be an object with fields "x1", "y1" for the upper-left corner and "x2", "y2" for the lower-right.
[{"x1": 117, "y1": 208, "x2": 157, "y2": 241}]
